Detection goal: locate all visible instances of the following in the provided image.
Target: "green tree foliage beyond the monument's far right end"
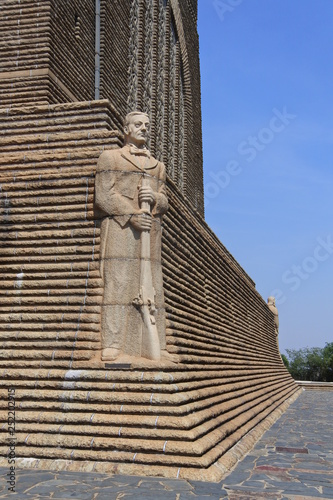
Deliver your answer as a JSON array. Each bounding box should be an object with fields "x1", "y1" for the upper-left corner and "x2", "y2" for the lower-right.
[{"x1": 282, "y1": 342, "x2": 333, "y2": 382}]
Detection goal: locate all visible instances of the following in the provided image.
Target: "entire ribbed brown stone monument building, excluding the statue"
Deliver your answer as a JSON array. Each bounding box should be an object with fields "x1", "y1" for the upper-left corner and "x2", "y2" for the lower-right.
[{"x1": 0, "y1": 0, "x2": 299, "y2": 480}]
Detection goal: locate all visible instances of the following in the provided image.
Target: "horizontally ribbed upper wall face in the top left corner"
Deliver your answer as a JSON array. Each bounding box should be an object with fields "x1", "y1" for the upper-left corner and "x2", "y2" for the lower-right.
[{"x1": 0, "y1": 0, "x2": 51, "y2": 106}]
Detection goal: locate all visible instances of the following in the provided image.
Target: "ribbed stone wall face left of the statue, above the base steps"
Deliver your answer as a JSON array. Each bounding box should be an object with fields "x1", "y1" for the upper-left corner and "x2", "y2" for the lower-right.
[{"x1": 0, "y1": 101, "x2": 119, "y2": 366}]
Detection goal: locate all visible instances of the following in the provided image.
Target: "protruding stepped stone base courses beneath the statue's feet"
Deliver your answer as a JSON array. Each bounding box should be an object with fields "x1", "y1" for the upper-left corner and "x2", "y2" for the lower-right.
[{"x1": 1, "y1": 363, "x2": 297, "y2": 468}]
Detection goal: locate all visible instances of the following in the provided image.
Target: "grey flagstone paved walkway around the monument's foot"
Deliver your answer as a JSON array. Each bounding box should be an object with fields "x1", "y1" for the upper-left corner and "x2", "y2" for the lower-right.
[{"x1": 0, "y1": 390, "x2": 333, "y2": 500}]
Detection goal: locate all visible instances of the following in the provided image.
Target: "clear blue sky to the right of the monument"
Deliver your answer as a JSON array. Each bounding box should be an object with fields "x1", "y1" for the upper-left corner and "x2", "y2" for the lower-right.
[{"x1": 198, "y1": 0, "x2": 333, "y2": 352}]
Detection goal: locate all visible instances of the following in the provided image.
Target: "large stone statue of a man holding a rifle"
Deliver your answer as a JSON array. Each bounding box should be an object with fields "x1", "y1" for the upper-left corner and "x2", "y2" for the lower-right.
[{"x1": 95, "y1": 111, "x2": 168, "y2": 361}]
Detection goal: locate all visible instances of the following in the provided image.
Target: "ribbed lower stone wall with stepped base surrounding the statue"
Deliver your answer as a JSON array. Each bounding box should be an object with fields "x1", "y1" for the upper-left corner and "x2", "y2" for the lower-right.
[{"x1": 0, "y1": 101, "x2": 298, "y2": 480}]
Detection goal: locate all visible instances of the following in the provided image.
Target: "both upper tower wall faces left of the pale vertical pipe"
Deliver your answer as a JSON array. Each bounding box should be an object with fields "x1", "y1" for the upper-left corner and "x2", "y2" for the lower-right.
[{"x1": 0, "y1": 0, "x2": 95, "y2": 105}]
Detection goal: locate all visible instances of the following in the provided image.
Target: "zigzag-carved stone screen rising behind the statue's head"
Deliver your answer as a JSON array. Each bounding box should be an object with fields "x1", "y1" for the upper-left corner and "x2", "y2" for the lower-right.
[{"x1": 128, "y1": 0, "x2": 186, "y2": 192}]
